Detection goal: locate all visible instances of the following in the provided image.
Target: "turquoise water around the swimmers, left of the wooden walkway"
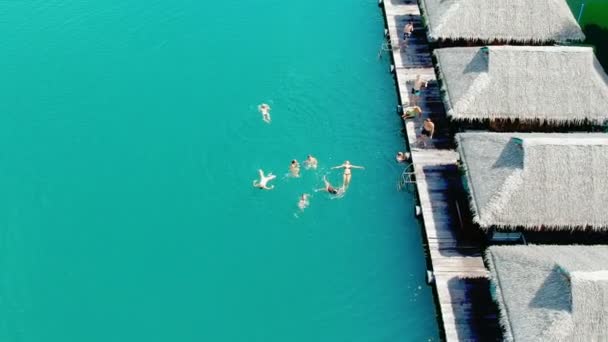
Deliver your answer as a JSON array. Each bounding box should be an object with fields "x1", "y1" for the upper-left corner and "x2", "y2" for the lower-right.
[{"x1": 0, "y1": 0, "x2": 438, "y2": 342}]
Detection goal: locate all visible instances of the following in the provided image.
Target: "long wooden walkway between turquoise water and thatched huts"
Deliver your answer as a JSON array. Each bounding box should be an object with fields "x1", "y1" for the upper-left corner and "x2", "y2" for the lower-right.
[{"x1": 383, "y1": 0, "x2": 501, "y2": 341}]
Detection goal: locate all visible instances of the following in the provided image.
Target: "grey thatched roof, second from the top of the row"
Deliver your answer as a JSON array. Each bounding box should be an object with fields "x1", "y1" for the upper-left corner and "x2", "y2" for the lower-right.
[{"x1": 435, "y1": 46, "x2": 608, "y2": 125}]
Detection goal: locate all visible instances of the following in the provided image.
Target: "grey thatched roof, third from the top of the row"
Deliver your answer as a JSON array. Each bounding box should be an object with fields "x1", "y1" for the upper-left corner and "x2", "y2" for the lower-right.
[{"x1": 456, "y1": 133, "x2": 608, "y2": 231}]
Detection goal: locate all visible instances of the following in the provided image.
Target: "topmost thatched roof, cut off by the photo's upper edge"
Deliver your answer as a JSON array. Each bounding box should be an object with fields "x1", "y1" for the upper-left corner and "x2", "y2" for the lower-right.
[{"x1": 420, "y1": 0, "x2": 585, "y2": 43}]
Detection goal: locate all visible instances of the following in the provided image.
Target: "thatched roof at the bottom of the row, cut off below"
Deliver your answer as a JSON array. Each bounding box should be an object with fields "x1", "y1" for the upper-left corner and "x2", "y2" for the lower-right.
[{"x1": 486, "y1": 246, "x2": 608, "y2": 341}]
